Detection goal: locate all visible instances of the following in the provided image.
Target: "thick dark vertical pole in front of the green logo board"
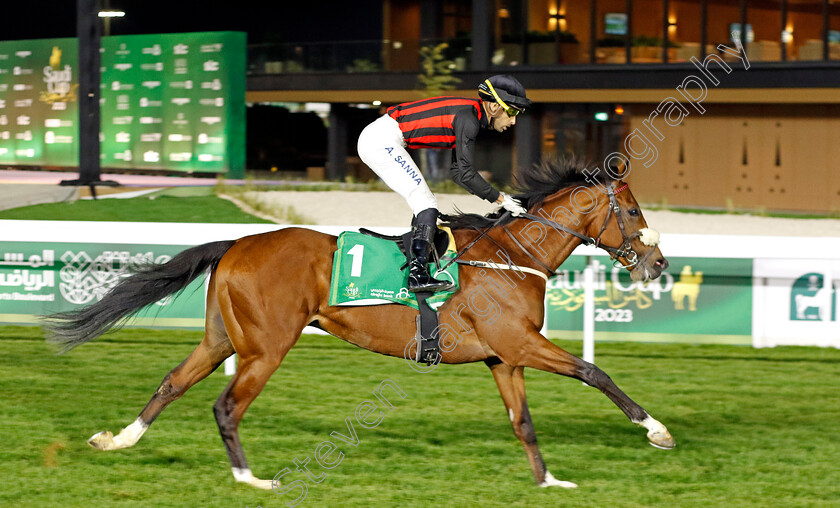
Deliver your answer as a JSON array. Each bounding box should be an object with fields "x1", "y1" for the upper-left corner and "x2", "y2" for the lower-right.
[{"x1": 59, "y1": 0, "x2": 119, "y2": 199}]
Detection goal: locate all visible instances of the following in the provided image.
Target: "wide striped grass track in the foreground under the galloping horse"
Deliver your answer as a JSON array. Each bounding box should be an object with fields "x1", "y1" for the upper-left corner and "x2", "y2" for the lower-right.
[{"x1": 0, "y1": 327, "x2": 840, "y2": 507}]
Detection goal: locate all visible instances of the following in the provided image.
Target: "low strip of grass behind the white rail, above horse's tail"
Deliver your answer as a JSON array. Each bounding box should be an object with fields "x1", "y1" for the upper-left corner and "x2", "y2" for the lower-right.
[{"x1": 0, "y1": 193, "x2": 271, "y2": 224}]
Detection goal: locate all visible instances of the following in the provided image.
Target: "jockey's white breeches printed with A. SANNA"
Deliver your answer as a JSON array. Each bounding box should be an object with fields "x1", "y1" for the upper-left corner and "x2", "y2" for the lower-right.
[{"x1": 357, "y1": 115, "x2": 437, "y2": 216}]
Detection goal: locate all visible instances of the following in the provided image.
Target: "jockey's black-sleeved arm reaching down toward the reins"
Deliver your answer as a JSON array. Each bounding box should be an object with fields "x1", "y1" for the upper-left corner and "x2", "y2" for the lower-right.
[{"x1": 449, "y1": 110, "x2": 502, "y2": 203}]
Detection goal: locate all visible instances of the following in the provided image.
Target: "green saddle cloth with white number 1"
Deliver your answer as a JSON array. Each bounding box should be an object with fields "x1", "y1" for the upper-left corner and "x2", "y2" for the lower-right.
[{"x1": 330, "y1": 228, "x2": 458, "y2": 309}]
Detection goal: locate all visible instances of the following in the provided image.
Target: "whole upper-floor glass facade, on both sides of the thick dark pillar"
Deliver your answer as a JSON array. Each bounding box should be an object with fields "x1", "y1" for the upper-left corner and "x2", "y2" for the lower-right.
[{"x1": 249, "y1": 0, "x2": 840, "y2": 74}]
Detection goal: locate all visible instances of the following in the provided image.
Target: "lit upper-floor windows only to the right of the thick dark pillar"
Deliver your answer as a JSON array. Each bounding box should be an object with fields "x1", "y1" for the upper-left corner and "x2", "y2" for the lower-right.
[{"x1": 493, "y1": 0, "x2": 840, "y2": 66}]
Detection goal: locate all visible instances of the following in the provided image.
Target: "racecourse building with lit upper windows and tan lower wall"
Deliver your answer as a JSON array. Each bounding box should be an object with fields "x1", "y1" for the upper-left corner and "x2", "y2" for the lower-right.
[{"x1": 247, "y1": 0, "x2": 840, "y2": 212}]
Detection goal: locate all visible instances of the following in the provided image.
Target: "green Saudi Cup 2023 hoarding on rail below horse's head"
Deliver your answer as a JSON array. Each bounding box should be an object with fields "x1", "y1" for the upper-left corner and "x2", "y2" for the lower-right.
[{"x1": 546, "y1": 256, "x2": 753, "y2": 345}]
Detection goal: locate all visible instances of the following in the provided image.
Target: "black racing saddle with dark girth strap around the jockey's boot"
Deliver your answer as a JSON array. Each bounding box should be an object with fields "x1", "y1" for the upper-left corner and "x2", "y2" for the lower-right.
[{"x1": 359, "y1": 228, "x2": 449, "y2": 365}]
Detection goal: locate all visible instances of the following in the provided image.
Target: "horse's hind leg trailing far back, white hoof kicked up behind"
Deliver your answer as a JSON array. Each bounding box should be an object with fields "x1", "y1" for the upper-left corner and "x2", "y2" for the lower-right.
[{"x1": 88, "y1": 281, "x2": 233, "y2": 450}]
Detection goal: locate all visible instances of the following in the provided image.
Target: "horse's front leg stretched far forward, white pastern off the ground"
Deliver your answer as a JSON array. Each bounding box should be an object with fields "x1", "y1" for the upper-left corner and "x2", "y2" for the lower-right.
[{"x1": 496, "y1": 330, "x2": 676, "y2": 450}]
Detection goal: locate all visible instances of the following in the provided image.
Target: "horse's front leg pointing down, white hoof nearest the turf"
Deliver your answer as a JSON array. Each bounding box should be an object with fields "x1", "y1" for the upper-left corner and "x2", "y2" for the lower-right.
[{"x1": 485, "y1": 358, "x2": 577, "y2": 489}]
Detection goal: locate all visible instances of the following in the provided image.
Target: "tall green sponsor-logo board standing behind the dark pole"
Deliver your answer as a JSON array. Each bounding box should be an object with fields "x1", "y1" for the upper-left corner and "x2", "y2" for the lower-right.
[{"x1": 0, "y1": 32, "x2": 246, "y2": 177}]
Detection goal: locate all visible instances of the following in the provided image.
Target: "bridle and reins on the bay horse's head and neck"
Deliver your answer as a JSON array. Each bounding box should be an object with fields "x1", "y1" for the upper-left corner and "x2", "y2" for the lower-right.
[{"x1": 443, "y1": 182, "x2": 642, "y2": 276}]
